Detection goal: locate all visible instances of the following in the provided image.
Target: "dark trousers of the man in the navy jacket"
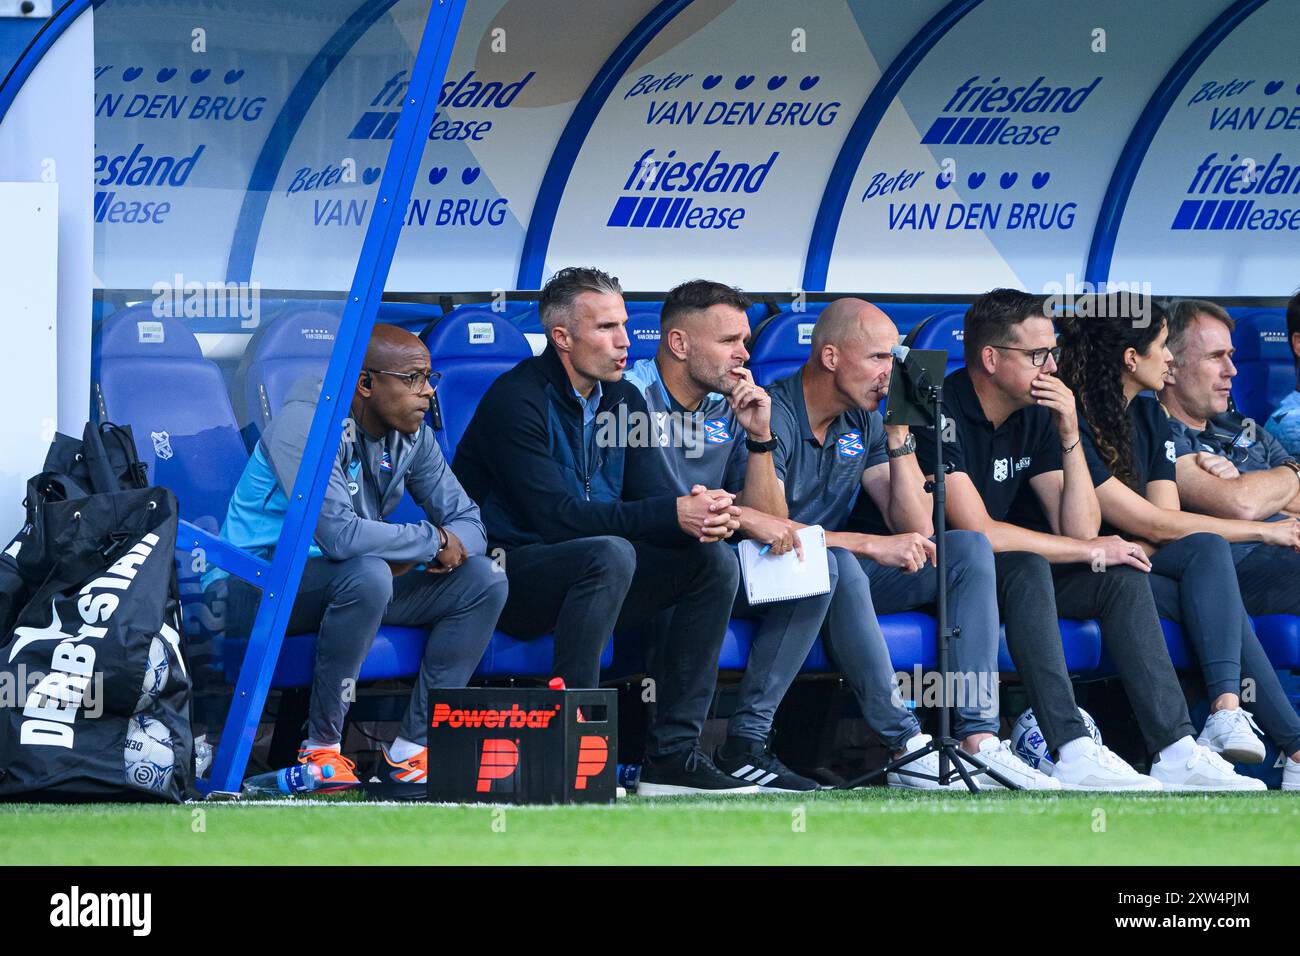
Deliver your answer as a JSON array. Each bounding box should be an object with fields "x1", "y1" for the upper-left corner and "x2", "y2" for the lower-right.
[{"x1": 499, "y1": 536, "x2": 740, "y2": 757}]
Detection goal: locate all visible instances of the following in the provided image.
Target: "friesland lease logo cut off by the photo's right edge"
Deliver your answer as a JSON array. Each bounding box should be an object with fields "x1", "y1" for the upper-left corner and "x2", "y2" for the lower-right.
[{"x1": 1170, "y1": 152, "x2": 1300, "y2": 232}]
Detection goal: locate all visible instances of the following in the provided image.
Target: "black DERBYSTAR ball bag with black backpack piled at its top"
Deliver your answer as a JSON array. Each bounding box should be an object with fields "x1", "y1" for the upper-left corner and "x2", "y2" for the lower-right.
[{"x1": 0, "y1": 427, "x2": 194, "y2": 801}]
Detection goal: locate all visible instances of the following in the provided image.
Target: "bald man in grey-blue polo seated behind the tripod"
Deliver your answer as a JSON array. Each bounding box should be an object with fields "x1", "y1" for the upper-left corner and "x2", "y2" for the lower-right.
[{"x1": 770, "y1": 299, "x2": 1060, "y2": 790}]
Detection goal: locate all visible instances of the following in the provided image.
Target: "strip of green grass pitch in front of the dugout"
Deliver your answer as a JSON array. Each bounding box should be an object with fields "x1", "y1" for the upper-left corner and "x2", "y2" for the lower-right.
[{"x1": 0, "y1": 788, "x2": 1300, "y2": 866}]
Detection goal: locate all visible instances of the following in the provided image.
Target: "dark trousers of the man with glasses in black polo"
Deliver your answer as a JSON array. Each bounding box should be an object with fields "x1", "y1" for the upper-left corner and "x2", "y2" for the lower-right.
[{"x1": 993, "y1": 551, "x2": 1195, "y2": 754}]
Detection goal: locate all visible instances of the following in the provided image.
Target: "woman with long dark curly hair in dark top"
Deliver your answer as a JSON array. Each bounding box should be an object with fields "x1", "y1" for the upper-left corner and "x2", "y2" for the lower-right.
[{"x1": 1060, "y1": 303, "x2": 1300, "y2": 779}]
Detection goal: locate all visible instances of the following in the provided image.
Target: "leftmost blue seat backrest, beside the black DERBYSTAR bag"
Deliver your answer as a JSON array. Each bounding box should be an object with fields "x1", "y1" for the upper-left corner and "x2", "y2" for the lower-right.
[{"x1": 95, "y1": 306, "x2": 247, "y2": 532}]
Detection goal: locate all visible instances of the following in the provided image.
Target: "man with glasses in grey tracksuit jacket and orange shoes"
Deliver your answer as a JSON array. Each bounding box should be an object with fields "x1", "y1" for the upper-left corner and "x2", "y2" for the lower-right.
[{"x1": 213, "y1": 325, "x2": 506, "y2": 790}]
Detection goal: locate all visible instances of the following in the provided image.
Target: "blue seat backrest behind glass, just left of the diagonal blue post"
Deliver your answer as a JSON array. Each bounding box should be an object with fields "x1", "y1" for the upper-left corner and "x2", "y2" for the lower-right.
[{"x1": 241, "y1": 303, "x2": 343, "y2": 432}]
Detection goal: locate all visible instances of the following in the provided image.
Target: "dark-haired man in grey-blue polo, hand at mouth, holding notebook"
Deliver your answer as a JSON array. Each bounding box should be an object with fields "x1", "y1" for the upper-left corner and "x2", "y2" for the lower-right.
[{"x1": 627, "y1": 280, "x2": 831, "y2": 792}]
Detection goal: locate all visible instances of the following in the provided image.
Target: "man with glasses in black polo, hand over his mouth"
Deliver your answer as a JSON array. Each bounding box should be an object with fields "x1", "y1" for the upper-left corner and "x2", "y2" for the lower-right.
[{"x1": 917, "y1": 289, "x2": 1216, "y2": 791}]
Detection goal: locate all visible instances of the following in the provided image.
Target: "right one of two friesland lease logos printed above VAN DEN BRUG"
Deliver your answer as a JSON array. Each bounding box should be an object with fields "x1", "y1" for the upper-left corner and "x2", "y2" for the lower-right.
[{"x1": 920, "y1": 74, "x2": 1101, "y2": 146}]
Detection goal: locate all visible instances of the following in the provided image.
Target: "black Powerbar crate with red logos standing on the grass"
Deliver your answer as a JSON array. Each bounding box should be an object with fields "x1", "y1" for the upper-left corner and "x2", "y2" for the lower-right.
[{"x1": 428, "y1": 687, "x2": 619, "y2": 804}]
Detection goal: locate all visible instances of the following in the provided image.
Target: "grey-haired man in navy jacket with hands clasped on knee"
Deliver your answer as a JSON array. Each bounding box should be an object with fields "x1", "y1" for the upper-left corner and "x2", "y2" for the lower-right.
[{"x1": 454, "y1": 268, "x2": 757, "y2": 796}]
